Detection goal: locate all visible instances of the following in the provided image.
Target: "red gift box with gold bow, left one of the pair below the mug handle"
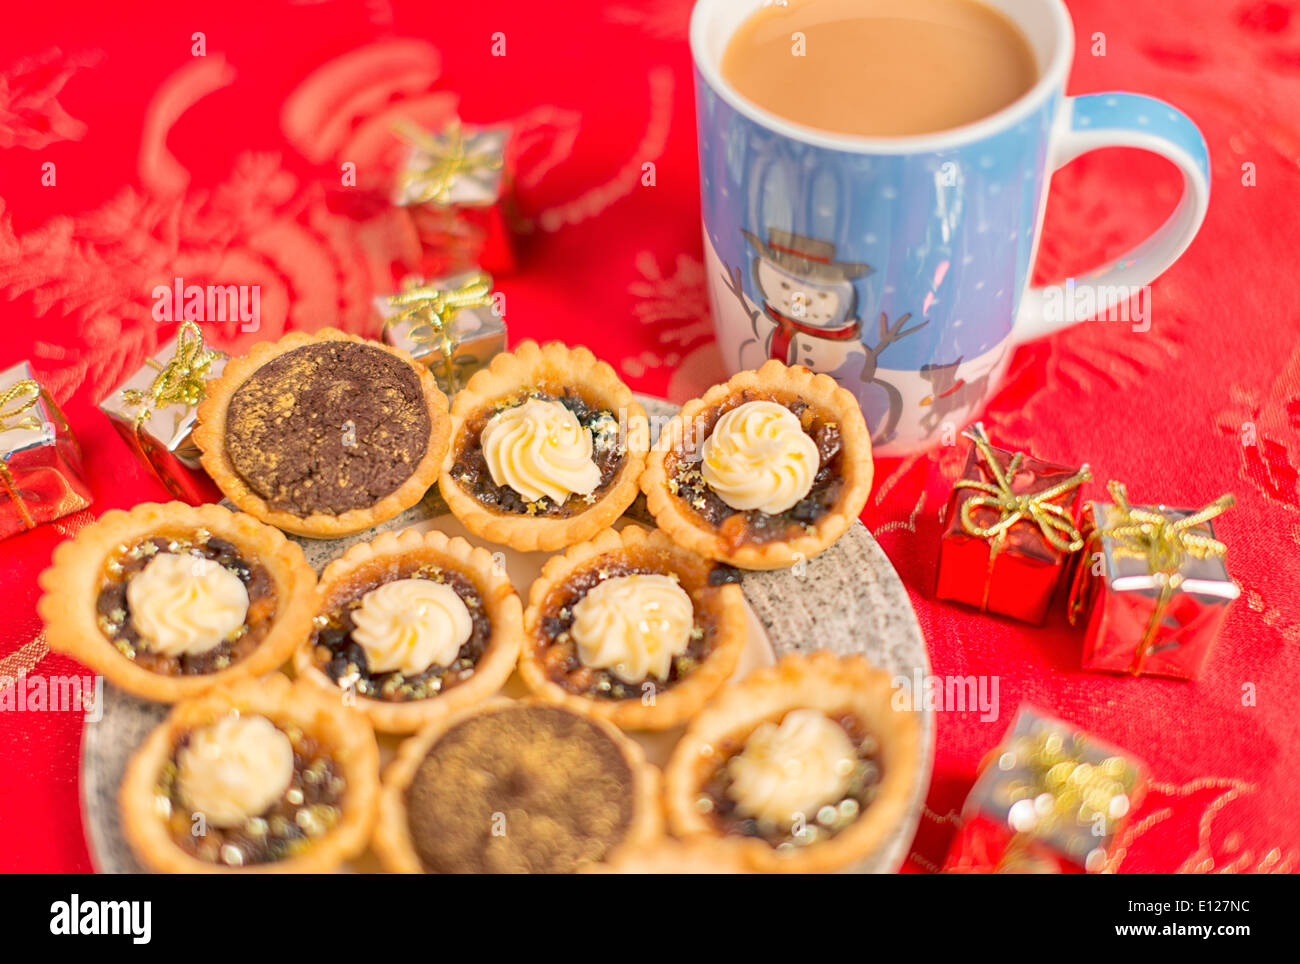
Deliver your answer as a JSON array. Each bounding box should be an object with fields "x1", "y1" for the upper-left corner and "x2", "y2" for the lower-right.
[{"x1": 935, "y1": 425, "x2": 1092, "y2": 624}]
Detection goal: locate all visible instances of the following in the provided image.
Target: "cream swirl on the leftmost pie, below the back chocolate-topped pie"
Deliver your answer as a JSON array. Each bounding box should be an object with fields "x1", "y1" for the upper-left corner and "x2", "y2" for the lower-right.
[{"x1": 126, "y1": 552, "x2": 248, "y2": 656}]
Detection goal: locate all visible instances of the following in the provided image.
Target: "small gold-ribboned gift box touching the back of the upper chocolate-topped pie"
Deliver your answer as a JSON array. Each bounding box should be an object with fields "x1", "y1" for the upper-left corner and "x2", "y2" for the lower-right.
[{"x1": 374, "y1": 272, "x2": 506, "y2": 395}]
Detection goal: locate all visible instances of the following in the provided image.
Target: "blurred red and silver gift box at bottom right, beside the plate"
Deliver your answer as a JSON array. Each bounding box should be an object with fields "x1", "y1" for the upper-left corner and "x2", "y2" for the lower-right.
[{"x1": 944, "y1": 705, "x2": 1148, "y2": 873}]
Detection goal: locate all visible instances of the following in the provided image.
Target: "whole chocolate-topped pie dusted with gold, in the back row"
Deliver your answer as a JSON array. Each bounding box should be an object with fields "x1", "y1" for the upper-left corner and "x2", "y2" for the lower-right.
[{"x1": 194, "y1": 329, "x2": 451, "y2": 538}]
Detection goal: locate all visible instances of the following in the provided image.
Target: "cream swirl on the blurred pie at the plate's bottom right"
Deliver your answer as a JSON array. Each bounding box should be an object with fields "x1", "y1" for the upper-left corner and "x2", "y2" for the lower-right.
[{"x1": 727, "y1": 709, "x2": 857, "y2": 826}]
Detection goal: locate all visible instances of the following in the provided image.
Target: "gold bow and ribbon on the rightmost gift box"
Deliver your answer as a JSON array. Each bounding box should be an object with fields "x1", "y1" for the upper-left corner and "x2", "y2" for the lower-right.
[{"x1": 1092, "y1": 481, "x2": 1236, "y2": 676}]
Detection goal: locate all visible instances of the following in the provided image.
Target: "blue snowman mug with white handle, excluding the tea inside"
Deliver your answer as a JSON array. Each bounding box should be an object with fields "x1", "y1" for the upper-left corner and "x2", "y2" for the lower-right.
[{"x1": 690, "y1": 0, "x2": 1210, "y2": 456}]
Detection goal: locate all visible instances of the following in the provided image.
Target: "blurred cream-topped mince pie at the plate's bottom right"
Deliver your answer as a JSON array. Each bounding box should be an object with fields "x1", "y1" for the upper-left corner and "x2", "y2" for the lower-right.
[{"x1": 664, "y1": 652, "x2": 920, "y2": 873}]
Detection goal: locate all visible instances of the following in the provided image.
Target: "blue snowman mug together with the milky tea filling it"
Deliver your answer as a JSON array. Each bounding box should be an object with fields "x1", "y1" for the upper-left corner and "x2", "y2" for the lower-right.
[{"x1": 690, "y1": 0, "x2": 1209, "y2": 456}]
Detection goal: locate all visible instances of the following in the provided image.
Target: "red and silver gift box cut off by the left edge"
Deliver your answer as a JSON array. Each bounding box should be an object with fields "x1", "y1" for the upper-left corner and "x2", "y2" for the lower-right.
[{"x1": 0, "y1": 361, "x2": 91, "y2": 539}]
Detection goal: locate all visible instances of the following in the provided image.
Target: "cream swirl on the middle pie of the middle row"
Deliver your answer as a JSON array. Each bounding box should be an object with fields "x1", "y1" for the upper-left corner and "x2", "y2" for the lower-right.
[{"x1": 352, "y1": 579, "x2": 473, "y2": 676}]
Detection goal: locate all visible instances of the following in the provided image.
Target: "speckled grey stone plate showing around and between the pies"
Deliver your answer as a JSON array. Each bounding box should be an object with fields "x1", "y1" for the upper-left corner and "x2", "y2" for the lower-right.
[{"x1": 81, "y1": 396, "x2": 935, "y2": 873}]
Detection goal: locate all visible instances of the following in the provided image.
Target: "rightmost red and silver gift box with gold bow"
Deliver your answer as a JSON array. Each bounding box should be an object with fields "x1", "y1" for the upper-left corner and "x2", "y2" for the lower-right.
[{"x1": 1070, "y1": 482, "x2": 1242, "y2": 679}]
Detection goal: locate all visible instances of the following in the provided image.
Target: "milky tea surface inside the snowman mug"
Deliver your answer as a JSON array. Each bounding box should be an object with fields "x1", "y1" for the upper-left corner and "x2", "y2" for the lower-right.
[{"x1": 723, "y1": 0, "x2": 1037, "y2": 136}]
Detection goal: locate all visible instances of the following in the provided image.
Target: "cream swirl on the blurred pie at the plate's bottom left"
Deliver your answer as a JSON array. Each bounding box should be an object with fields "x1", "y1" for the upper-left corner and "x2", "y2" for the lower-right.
[{"x1": 177, "y1": 713, "x2": 294, "y2": 826}]
